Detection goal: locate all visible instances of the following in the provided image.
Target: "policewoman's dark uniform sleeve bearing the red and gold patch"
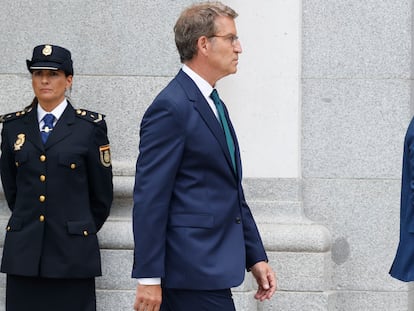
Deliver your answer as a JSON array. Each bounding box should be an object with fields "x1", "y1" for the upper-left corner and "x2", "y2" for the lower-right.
[{"x1": 88, "y1": 121, "x2": 113, "y2": 230}]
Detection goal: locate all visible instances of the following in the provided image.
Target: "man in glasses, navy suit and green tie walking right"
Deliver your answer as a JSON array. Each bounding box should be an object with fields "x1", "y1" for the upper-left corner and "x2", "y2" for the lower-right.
[{"x1": 132, "y1": 2, "x2": 276, "y2": 311}]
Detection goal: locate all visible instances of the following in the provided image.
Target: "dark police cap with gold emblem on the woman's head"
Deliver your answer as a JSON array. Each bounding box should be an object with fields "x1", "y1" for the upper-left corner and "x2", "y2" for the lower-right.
[{"x1": 26, "y1": 44, "x2": 73, "y2": 75}]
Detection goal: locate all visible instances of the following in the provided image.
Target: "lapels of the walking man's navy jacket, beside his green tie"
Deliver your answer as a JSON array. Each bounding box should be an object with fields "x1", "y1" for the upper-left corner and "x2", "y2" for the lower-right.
[{"x1": 176, "y1": 70, "x2": 239, "y2": 178}]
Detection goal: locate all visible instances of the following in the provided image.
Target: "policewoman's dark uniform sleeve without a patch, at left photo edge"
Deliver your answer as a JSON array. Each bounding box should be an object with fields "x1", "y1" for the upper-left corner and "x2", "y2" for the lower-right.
[{"x1": 0, "y1": 124, "x2": 17, "y2": 211}]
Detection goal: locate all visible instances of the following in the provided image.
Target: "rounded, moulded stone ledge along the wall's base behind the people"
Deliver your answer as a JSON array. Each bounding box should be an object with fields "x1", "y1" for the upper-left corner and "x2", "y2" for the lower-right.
[{"x1": 0, "y1": 175, "x2": 331, "y2": 258}]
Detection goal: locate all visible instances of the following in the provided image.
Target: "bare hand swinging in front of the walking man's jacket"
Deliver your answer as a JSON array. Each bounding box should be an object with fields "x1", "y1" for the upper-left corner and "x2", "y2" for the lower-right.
[{"x1": 250, "y1": 261, "x2": 276, "y2": 301}]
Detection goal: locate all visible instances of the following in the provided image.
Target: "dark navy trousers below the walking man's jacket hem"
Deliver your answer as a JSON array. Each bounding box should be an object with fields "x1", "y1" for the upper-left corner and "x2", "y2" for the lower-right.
[{"x1": 160, "y1": 288, "x2": 236, "y2": 311}]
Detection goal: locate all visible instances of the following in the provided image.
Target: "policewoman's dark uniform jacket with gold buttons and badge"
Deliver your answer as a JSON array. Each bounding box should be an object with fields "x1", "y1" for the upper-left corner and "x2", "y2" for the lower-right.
[{"x1": 0, "y1": 103, "x2": 113, "y2": 278}]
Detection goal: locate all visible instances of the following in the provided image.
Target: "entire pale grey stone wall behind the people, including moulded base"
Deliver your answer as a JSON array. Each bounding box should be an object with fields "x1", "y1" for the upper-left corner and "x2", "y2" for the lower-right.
[{"x1": 0, "y1": 0, "x2": 414, "y2": 311}]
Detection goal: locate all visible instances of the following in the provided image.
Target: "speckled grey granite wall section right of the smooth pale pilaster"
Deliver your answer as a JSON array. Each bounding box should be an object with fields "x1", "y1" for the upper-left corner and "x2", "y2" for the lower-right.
[{"x1": 302, "y1": 0, "x2": 414, "y2": 311}]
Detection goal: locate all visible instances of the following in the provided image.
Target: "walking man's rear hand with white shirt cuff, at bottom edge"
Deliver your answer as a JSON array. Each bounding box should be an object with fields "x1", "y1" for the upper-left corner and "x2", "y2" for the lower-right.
[{"x1": 134, "y1": 284, "x2": 162, "y2": 311}]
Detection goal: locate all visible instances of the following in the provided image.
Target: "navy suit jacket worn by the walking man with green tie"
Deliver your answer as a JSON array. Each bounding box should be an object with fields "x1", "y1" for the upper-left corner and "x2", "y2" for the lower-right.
[{"x1": 132, "y1": 71, "x2": 267, "y2": 290}]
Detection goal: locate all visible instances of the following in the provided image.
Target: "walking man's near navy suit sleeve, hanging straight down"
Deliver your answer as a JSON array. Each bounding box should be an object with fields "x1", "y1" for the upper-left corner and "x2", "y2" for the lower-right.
[{"x1": 132, "y1": 100, "x2": 184, "y2": 278}]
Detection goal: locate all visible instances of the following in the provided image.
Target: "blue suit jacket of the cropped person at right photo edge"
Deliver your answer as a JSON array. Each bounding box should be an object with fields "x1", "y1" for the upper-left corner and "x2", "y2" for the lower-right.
[{"x1": 390, "y1": 119, "x2": 414, "y2": 282}]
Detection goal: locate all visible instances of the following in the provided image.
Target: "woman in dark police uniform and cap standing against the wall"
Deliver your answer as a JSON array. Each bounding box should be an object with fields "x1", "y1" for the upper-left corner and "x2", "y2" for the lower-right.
[{"x1": 0, "y1": 45, "x2": 113, "y2": 311}]
